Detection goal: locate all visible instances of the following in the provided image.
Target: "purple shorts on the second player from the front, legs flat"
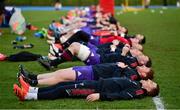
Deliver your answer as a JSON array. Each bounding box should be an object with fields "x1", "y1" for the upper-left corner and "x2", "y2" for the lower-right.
[{"x1": 72, "y1": 66, "x2": 94, "y2": 81}]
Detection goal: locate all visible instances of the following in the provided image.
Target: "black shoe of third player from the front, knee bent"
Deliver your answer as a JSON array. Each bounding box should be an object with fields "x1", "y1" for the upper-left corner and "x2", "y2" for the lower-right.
[{"x1": 38, "y1": 57, "x2": 53, "y2": 70}]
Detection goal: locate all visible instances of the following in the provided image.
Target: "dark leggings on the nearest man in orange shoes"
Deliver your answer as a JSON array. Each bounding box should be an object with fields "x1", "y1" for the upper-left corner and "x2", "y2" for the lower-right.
[{"x1": 38, "y1": 81, "x2": 98, "y2": 100}]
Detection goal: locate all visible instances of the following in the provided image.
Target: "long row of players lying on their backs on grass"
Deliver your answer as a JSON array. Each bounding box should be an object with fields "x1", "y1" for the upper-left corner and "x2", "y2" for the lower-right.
[{"x1": 14, "y1": 7, "x2": 159, "y2": 101}]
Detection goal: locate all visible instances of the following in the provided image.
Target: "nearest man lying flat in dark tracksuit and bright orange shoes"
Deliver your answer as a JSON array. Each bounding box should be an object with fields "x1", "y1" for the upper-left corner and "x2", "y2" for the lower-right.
[{"x1": 14, "y1": 77, "x2": 159, "y2": 102}]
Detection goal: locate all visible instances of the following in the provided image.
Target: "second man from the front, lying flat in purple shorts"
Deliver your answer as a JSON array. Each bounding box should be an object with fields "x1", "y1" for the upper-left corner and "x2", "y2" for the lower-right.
[{"x1": 18, "y1": 62, "x2": 153, "y2": 86}]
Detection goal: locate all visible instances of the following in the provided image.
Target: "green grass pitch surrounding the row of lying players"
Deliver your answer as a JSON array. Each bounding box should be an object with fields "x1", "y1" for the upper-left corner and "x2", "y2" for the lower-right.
[{"x1": 0, "y1": 8, "x2": 180, "y2": 109}]
